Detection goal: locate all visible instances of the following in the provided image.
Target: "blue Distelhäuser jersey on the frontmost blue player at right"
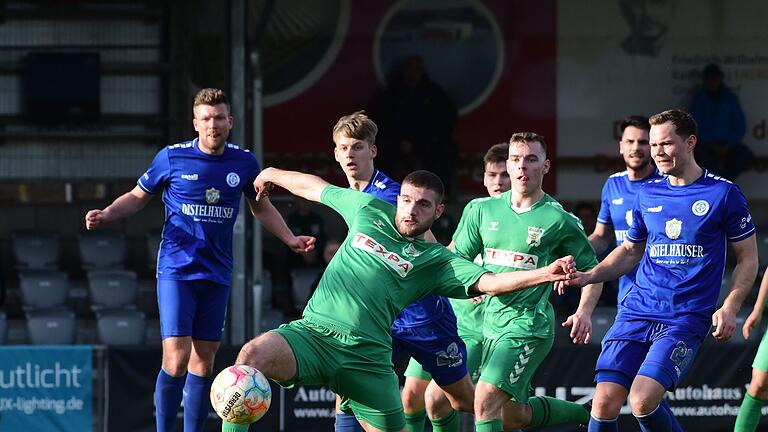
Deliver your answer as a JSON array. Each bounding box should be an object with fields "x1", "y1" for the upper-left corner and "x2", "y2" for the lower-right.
[{"x1": 619, "y1": 170, "x2": 755, "y2": 324}]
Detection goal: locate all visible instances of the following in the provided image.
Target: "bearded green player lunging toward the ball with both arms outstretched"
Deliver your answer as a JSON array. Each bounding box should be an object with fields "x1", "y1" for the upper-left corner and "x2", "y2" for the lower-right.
[{"x1": 228, "y1": 168, "x2": 575, "y2": 432}]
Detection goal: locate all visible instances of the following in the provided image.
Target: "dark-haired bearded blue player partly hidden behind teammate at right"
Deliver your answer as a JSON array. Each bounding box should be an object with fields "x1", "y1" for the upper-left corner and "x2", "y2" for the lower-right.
[{"x1": 589, "y1": 116, "x2": 660, "y2": 301}]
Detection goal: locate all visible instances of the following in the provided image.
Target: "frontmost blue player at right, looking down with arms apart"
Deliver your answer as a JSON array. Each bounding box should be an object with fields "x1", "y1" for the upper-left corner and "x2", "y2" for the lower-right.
[{"x1": 555, "y1": 110, "x2": 757, "y2": 432}]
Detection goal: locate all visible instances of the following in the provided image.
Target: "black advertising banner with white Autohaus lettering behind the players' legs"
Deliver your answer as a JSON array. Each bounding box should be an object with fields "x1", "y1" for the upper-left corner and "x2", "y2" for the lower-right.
[{"x1": 108, "y1": 341, "x2": 768, "y2": 432}]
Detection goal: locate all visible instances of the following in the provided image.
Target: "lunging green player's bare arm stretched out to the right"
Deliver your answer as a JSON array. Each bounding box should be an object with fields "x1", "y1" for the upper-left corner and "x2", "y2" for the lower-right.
[{"x1": 470, "y1": 256, "x2": 573, "y2": 296}]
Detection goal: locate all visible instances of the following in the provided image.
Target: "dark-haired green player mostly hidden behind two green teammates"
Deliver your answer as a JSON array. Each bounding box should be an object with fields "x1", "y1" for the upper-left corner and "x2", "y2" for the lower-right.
[{"x1": 405, "y1": 143, "x2": 512, "y2": 432}]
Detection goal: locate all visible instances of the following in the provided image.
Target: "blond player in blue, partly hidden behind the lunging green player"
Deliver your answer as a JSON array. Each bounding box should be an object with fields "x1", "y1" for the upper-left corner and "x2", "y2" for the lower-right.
[{"x1": 333, "y1": 112, "x2": 474, "y2": 432}]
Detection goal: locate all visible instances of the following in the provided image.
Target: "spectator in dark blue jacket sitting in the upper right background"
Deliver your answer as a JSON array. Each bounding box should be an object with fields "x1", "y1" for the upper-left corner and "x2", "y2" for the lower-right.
[{"x1": 691, "y1": 64, "x2": 754, "y2": 180}]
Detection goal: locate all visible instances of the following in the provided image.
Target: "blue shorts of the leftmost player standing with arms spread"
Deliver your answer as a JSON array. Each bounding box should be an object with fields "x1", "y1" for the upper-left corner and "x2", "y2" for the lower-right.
[{"x1": 157, "y1": 279, "x2": 230, "y2": 341}]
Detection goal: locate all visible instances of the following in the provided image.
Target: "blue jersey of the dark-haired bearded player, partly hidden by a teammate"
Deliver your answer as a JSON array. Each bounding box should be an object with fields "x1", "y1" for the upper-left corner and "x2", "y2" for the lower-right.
[{"x1": 597, "y1": 170, "x2": 661, "y2": 301}]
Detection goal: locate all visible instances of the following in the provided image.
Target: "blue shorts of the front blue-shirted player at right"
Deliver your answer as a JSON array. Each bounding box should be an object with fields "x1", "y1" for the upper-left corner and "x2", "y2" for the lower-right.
[{"x1": 595, "y1": 315, "x2": 709, "y2": 390}]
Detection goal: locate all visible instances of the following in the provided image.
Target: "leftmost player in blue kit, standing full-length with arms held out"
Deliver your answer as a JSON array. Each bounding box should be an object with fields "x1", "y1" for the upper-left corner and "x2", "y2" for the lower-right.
[{"x1": 85, "y1": 88, "x2": 315, "y2": 432}]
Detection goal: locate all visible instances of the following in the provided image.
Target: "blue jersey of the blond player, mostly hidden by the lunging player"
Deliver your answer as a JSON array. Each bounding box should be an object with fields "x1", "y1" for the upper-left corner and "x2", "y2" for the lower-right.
[{"x1": 363, "y1": 170, "x2": 455, "y2": 327}]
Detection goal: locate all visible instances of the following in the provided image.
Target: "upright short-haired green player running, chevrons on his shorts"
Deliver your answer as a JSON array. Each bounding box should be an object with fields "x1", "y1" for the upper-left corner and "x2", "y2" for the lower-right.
[{"x1": 453, "y1": 132, "x2": 602, "y2": 432}]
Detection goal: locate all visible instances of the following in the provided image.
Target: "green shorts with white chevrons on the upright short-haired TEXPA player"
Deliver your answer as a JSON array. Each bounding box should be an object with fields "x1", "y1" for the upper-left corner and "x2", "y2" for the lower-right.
[{"x1": 480, "y1": 336, "x2": 554, "y2": 403}]
